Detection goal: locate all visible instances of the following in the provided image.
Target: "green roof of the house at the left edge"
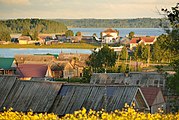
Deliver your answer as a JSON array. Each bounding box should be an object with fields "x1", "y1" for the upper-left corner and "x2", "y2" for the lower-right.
[{"x1": 0, "y1": 57, "x2": 14, "y2": 70}]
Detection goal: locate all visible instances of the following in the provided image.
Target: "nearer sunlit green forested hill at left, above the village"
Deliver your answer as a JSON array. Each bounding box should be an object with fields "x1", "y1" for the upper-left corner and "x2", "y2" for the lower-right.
[{"x1": 0, "y1": 19, "x2": 67, "y2": 33}]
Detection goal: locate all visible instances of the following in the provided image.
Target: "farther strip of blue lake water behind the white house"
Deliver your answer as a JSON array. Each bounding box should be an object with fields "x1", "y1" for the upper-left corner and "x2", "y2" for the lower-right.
[{"x1": 69, "y1": 28, "x2": 165, "y2": 37}]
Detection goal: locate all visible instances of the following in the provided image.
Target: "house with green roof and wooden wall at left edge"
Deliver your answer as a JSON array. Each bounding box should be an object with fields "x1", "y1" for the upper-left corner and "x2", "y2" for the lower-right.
[{"x1": 0, "y1": 57, "x2": 16, "y2": 75}]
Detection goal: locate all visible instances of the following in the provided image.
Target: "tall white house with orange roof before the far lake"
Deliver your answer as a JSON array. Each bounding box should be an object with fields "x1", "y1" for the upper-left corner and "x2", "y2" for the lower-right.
[{"x1": 101, "y1": 28, "x2": 119, "y2": 44}]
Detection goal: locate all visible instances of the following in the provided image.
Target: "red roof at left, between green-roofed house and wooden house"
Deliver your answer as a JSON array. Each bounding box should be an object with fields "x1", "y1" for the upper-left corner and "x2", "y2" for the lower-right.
[{"x1": 17, "y1": 64, "x2": 47, "y2": 77}]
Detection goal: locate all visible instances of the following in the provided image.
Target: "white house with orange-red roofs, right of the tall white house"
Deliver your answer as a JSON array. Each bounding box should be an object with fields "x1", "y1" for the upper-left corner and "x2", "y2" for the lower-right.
[{"x1": 130, "y1": 36, "x2": 157, "y2": 50}]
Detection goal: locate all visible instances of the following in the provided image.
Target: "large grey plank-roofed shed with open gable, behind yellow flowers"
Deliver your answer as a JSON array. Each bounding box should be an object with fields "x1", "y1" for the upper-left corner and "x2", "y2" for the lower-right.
[{"x1": 50, "y1": 84, "x2": 149, "y2": 115}]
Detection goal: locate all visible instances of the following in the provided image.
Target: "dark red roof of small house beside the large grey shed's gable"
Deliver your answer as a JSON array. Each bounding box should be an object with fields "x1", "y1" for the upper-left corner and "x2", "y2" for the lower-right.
[{"x1": 141, "y1": 87, "x2": 161, "y2": 106}]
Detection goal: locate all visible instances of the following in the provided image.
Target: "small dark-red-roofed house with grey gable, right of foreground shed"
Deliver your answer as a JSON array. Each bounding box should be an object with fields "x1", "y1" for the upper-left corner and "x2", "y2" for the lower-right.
[{"x1": 141, "y1": 87, "x2": 166, "y2": 113}]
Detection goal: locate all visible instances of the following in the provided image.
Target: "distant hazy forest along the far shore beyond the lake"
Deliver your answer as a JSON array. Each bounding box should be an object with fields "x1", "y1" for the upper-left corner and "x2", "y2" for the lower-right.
[{"x1": 53, "y1": 18, "x2": 161, "y2": 28}]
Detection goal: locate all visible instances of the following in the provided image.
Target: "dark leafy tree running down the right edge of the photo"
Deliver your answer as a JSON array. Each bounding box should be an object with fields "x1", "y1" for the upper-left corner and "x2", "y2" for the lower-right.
[{"x1": 162, "y1": 3, "x2": 179, "y2": 111}]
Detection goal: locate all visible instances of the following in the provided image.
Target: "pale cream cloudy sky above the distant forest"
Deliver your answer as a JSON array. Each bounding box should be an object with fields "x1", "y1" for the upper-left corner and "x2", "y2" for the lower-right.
[{"x1": 0, "y1": 0, "x2": 178, "y2": 19}]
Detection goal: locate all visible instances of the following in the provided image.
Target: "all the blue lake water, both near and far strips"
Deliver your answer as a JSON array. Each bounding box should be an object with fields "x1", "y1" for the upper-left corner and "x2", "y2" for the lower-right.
[{"x1": 0, "y1": 28, "x2": 165, "y2": 57}]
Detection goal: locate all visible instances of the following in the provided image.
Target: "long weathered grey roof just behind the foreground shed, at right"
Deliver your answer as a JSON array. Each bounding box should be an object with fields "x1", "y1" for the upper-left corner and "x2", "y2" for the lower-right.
[{"x1": 90, "y1": 72, "x2": 165, "y2": 87}]
